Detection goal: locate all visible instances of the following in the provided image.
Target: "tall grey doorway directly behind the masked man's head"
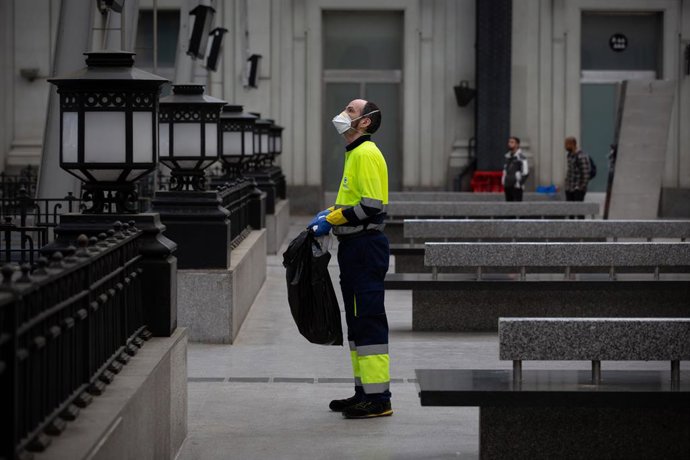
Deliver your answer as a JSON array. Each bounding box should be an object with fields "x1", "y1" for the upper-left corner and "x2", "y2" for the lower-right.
[{"x1": 322, "y1": 10, "x2": 403, "y2": 191}]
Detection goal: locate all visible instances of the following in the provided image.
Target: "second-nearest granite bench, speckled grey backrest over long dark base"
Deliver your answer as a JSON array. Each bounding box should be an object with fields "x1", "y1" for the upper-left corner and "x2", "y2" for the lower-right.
[{"x1": 385, "y1": 242, "x2": 690, "y2": 332}]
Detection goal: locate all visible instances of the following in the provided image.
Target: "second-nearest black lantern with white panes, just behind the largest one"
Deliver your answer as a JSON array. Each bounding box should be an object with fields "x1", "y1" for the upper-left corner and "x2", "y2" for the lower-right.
[{"x1": 159, "y1": 84, "x2": 225, "y2": 190}]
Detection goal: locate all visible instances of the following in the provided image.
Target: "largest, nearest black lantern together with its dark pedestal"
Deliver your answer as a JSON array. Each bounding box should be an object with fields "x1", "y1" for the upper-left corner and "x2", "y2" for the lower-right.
[{"x1": 44, "y1": 51, "x2": 177, "y2": 336}]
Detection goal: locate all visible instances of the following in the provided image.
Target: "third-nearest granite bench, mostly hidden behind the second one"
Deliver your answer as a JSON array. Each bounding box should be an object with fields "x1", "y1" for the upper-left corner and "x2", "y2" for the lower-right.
[{"x1": 391, "y1": 219, "x2": 690, "y2": 273}]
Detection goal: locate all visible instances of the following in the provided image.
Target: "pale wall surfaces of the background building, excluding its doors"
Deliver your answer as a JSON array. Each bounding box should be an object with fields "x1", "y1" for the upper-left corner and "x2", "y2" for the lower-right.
[{"x1": 0, "y1": 0, "x2": 690, "y2": 192}]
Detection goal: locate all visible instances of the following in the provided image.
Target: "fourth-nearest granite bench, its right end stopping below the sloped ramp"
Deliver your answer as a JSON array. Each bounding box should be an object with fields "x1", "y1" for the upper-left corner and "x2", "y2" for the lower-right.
[{"x1": 386, "y1": 201, "x2": 599, "y2": 243}]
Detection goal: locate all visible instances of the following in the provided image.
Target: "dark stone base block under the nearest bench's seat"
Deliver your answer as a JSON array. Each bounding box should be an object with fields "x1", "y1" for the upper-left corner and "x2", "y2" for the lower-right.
[{"x1": 479, "y1": 406, "x2": 690, "y2": 460}]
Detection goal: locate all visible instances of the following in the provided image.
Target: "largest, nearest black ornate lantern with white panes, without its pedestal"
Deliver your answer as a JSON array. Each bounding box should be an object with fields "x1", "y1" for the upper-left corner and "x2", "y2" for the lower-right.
[{"x1": 48, "y1": 51, "x2": 168, "y2": 214}]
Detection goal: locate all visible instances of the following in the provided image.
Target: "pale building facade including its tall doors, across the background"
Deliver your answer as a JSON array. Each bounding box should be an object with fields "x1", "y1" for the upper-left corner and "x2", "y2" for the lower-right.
[{"x1": 0, "y1": 0, "x2": 690, "y2": 210}]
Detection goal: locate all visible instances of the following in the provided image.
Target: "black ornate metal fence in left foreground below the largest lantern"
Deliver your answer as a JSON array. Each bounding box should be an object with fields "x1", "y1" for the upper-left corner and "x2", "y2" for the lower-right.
[{"x1": 0, "y1": 223, "x2": 150, "y2": 460}]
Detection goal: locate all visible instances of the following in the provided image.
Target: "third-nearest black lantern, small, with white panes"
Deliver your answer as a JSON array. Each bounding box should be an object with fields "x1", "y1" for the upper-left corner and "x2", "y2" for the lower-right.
[{"x1": 220, "y1": 104, "x2": 258, "y2": 176}]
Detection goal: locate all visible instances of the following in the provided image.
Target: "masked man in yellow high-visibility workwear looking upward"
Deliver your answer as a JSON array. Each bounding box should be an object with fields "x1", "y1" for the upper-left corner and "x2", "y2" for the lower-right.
[{"x1": 308, "y1": 99, "x2": 393, "y2": 418}]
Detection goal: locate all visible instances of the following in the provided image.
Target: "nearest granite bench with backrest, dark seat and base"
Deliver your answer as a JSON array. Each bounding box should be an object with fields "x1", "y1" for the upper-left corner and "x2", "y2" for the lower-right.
[{"x1": 416, "y1": 318, "x2": 690, "y2": 459}]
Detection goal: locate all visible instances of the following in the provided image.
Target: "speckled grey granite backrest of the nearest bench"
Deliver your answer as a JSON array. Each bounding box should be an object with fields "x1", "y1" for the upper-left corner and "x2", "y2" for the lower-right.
[{"x1": 498, "y1": 318, "x2": 690, "y2": 361}]
